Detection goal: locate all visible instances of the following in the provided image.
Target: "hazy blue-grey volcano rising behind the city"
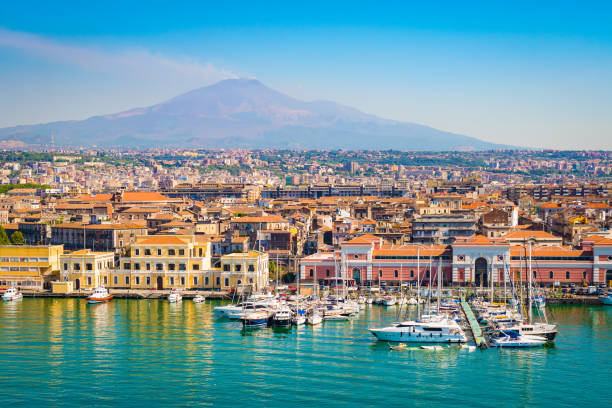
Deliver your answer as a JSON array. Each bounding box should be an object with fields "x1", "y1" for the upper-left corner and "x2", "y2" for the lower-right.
[{"x1": 0, "y1": 79, "x2": 510, "y2": 151}]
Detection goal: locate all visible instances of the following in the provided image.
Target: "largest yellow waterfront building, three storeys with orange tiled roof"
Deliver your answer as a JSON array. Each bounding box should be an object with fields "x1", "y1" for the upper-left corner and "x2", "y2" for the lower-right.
[{"x1": 115, "y1": 235, "x2": 211, "y2": 290}]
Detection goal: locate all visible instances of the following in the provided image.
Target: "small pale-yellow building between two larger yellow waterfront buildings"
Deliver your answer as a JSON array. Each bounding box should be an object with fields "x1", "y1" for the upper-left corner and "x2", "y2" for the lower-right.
[{"x1": 60, "y1": 249, "x2": 116, "y2": 290}]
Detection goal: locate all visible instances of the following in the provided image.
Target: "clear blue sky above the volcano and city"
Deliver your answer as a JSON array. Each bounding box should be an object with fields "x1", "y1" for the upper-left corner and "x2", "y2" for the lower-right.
[{"x1": 0, "y1": 0, "x2": 612, "y2": 150}]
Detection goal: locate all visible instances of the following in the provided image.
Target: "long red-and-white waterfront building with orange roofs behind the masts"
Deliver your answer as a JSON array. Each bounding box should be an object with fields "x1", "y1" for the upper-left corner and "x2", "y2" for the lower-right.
[{"x1": 300, "y1": 231, "x2": 612, "y2": 287}]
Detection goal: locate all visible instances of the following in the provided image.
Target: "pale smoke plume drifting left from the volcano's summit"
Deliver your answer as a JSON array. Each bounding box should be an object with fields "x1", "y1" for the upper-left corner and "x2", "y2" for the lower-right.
[{"x1": 0, "y1": 28, "x2": 236, "y2": 85}]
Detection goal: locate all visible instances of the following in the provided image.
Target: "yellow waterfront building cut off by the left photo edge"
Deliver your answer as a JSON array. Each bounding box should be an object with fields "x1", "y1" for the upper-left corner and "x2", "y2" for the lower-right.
[{"x1": 0, "y1": 245, "x2": 64, "y2": 290}]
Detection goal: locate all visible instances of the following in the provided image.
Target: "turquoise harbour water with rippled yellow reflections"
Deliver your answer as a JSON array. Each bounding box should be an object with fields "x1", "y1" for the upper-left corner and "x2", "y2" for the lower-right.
[{"x1": 0, "y1": 299, "x2": 612, "y2": 407}]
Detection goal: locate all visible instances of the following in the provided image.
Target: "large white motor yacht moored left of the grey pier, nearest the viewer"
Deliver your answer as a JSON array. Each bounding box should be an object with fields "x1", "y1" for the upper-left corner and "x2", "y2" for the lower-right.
[{"x1": 370, "y1": 319, "x2": 467, "y2": 343}]
